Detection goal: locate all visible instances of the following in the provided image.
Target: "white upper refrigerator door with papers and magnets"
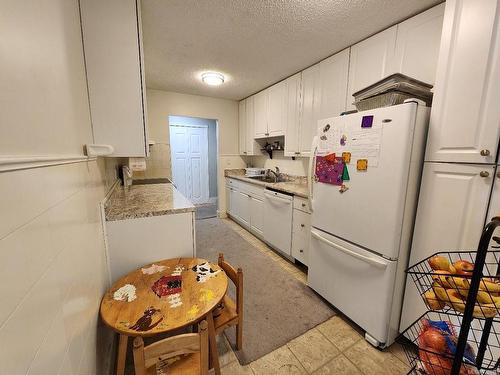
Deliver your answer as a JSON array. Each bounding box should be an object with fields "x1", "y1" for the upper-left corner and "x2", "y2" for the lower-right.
[{"x1": 312, "y1": 103, "x2": 423, "y2": 259}]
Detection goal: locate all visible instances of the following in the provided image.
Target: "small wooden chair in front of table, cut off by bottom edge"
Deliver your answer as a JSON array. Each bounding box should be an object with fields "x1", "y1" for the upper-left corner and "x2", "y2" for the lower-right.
[{"x1": 134, "y1": 320, "x2": 208, "y2": 375}]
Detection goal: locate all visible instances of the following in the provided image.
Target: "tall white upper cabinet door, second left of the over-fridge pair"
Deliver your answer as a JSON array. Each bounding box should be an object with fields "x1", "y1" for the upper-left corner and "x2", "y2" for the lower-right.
[{"x1": 298, "y1": 64, "x2": 321, "y2": 156}]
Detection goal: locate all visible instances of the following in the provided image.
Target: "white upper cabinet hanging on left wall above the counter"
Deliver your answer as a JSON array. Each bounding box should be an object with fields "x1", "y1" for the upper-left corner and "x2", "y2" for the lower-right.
[{"x1": 80, "y1": 0, "x2": 148, "y2": 156}]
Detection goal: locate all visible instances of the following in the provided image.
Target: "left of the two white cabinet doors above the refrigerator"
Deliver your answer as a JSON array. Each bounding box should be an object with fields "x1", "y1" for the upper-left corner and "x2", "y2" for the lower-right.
[{"x1": 346, "y1": 26, "x2": 397, "y2": 109}]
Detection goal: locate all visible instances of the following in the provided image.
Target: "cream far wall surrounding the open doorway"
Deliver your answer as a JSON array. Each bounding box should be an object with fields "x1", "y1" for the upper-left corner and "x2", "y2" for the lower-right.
[{"x1": 147, "y1": 89, "x2": 246, "y2": 212}]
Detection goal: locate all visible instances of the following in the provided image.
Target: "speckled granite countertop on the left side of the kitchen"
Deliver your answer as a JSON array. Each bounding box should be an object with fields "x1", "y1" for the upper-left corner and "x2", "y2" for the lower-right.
[{"x1": 105, "y1": 184, "x2": 195, "y2": 221}]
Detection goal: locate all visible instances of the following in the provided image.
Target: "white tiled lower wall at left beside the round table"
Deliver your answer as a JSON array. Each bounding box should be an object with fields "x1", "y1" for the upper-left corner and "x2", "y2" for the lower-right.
[{"x1": 0, "y1": 161, "x2": 112, "y2": 375}]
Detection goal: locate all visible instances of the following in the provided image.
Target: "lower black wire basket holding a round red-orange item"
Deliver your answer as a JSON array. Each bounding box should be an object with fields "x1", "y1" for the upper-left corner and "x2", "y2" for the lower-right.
[{"x1": 396, "y1": 311, "x2": 500, "y2": 375}]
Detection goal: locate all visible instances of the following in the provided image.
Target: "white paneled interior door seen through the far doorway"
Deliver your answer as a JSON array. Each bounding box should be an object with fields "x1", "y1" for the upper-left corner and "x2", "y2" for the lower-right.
[{"x1": 170, "y1": 125, "x2": 209, "y2": 204}]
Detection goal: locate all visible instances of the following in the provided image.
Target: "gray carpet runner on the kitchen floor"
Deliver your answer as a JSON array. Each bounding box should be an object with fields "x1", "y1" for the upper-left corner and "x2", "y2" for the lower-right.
[{"x1": 196, "y1": 219, "x2": 335, "y2": 365}]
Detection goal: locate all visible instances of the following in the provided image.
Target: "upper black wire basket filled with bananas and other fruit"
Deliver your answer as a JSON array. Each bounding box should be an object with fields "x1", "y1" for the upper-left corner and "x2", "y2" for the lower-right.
[{"x1": 407, "y1": 250, "x2": 500, "y2": 322}]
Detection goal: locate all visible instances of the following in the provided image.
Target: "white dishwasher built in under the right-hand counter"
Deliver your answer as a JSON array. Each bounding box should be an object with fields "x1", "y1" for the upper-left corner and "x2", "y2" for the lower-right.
[{"x1": 264, "y1": 189, "x2": 293, "y2": 256}]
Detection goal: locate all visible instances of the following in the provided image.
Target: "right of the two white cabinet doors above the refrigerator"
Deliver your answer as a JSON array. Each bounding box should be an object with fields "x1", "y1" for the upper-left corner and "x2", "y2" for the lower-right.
[{"x1": 394, "y1": 3, "x2": 445, "y2": 85}]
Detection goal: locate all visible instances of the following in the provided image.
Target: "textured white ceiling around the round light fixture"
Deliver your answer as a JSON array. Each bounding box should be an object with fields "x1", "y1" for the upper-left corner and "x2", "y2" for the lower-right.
[{"x1": 142, "y1": 0, "x2": 441, "y2": 99}]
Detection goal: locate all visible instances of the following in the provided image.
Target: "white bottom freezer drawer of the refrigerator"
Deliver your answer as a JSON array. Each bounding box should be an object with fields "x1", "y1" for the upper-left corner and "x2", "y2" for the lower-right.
[{"x1": 307, "y1": 229, "x2": 397, "y2": 343}]
